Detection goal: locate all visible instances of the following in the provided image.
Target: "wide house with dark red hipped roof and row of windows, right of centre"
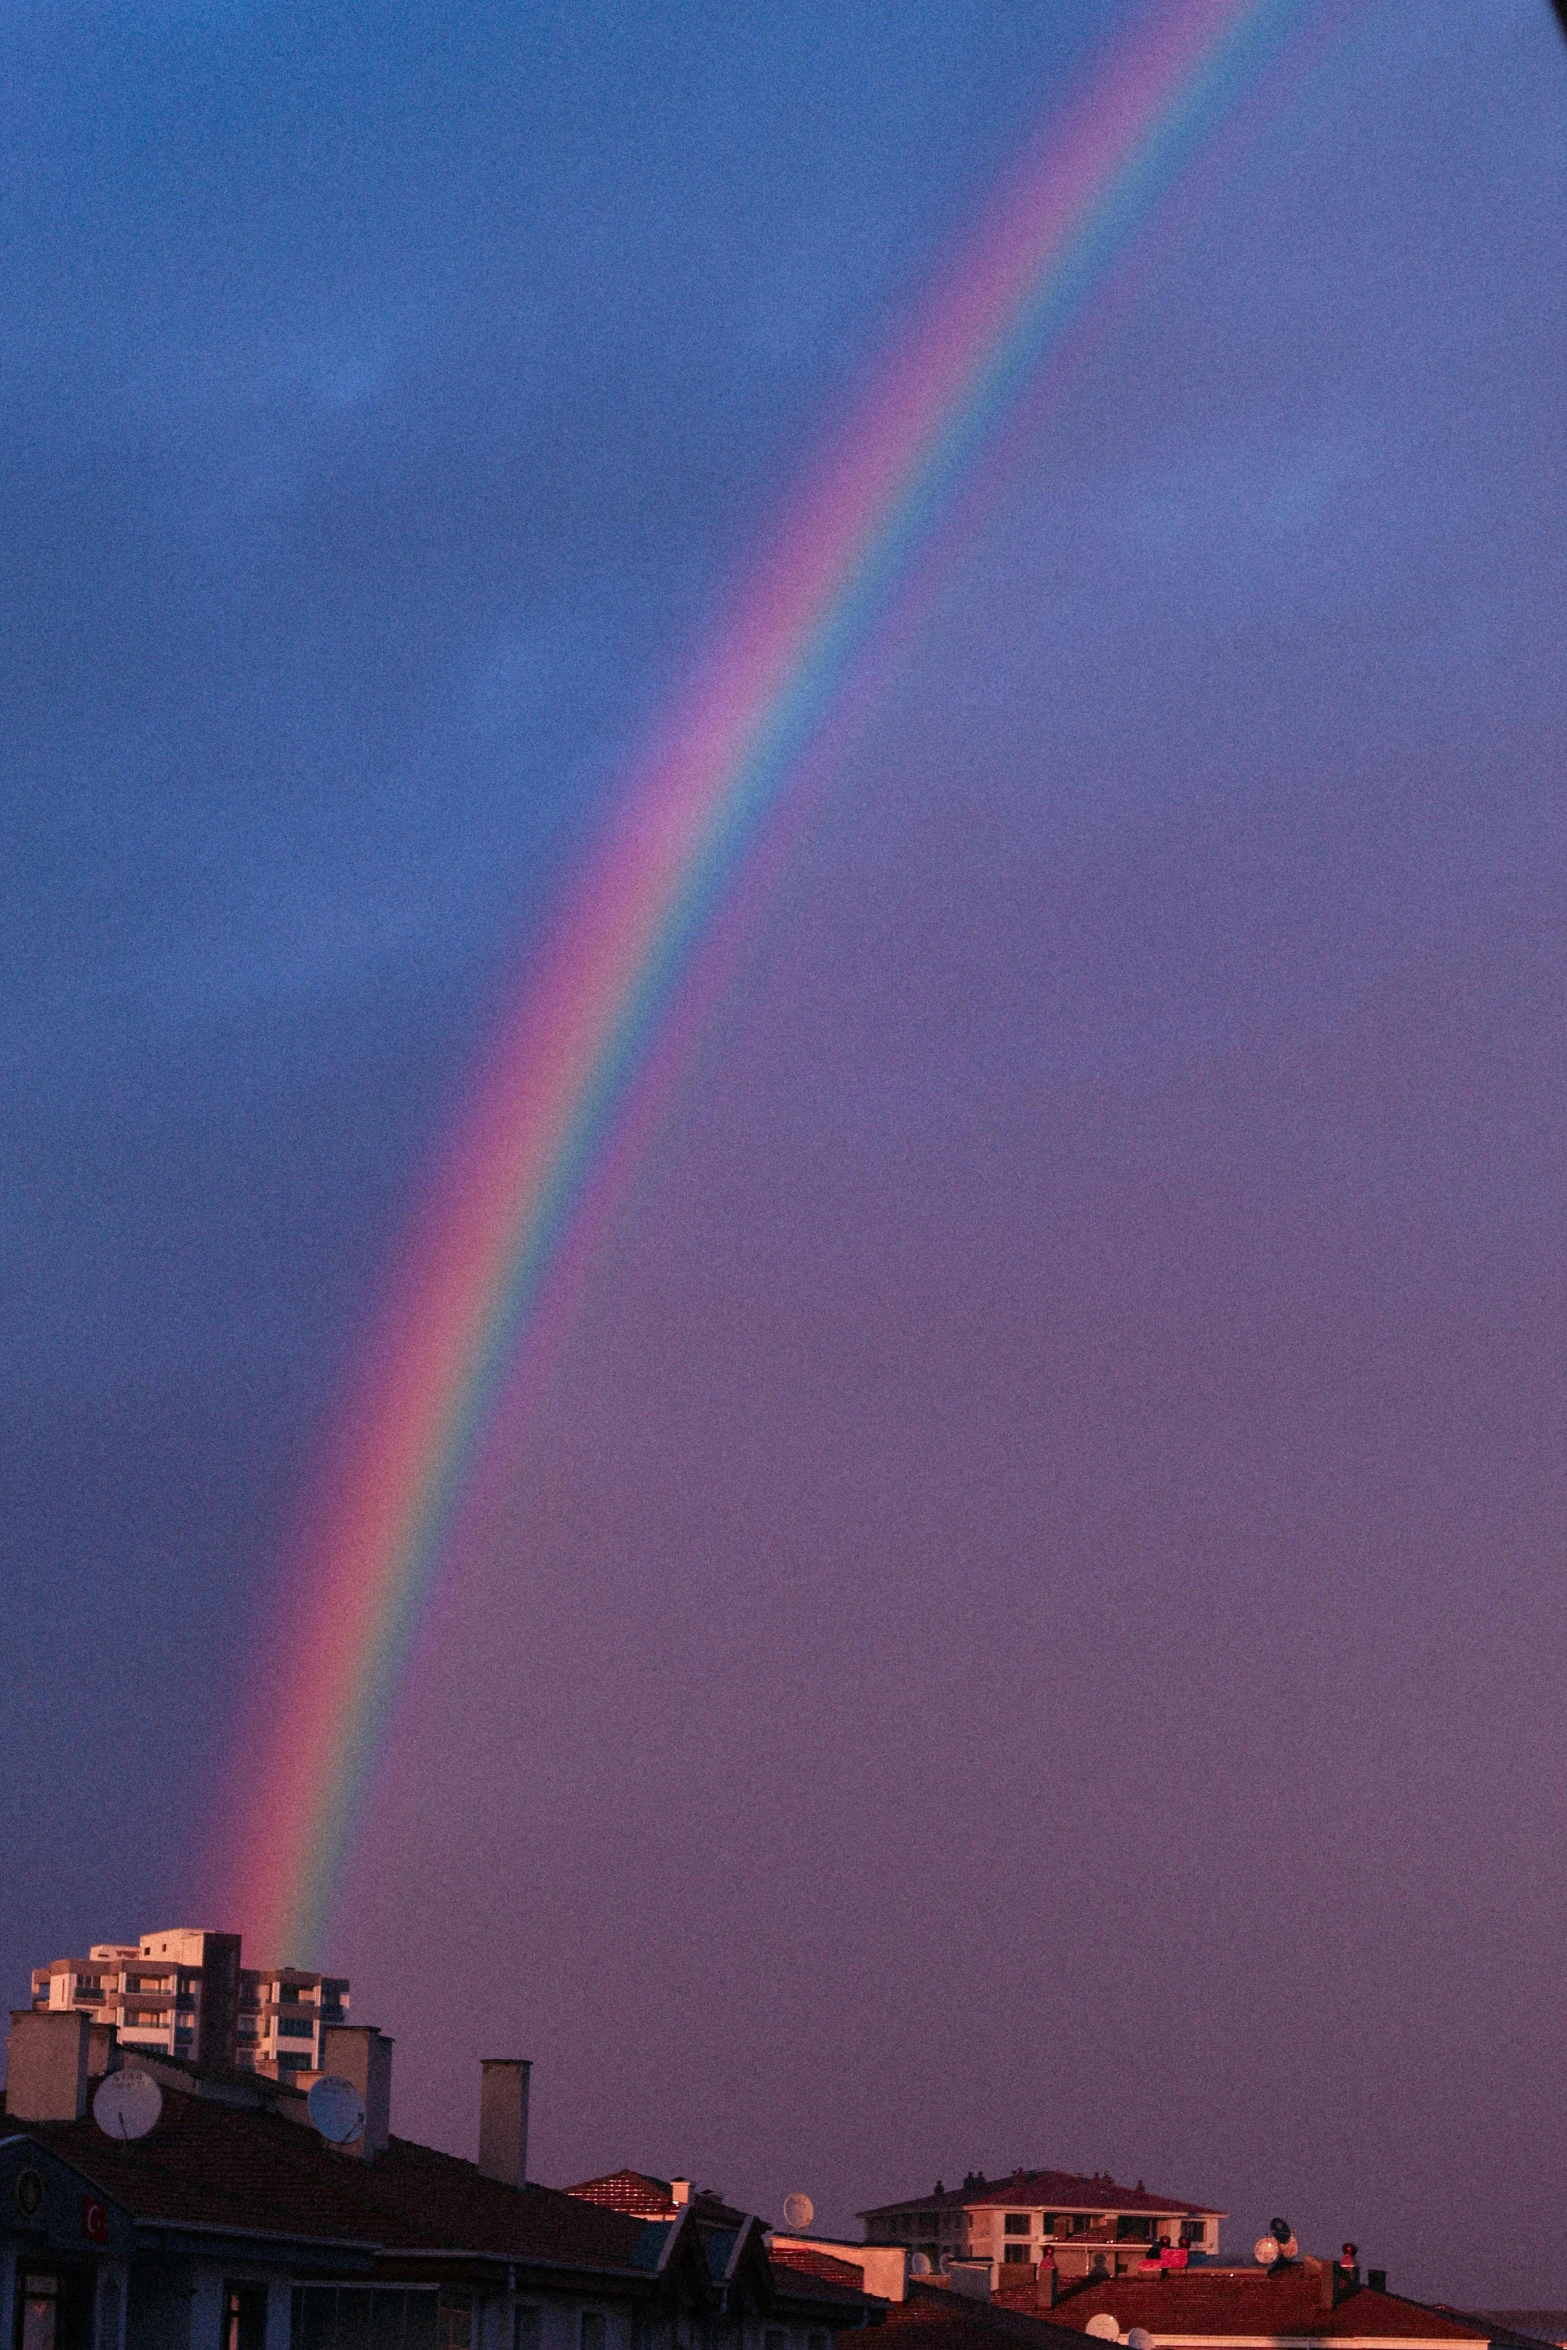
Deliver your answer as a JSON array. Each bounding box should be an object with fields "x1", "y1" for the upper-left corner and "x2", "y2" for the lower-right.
[{"x1": 860, "y1": 2171, "x2": 1229, "y2": 2280}]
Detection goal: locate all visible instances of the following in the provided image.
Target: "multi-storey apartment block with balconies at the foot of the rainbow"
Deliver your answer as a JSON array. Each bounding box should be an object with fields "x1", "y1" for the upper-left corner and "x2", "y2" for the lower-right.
[{"x1": 33, "y1": 1927, "x2": 348, "y2": 2080}]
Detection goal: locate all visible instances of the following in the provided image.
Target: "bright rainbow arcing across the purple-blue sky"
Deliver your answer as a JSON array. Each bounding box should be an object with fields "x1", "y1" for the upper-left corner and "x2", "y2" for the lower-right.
[{"x1": 218, "y1": 0, "x2": 1306, "y2": 1965}]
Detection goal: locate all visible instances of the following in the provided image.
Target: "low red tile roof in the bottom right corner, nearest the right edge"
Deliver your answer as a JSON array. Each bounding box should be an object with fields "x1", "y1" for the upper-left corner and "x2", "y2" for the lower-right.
[{"x1": 1019, "y1": 2261, "x2": 1508, "y2": 2343}]
